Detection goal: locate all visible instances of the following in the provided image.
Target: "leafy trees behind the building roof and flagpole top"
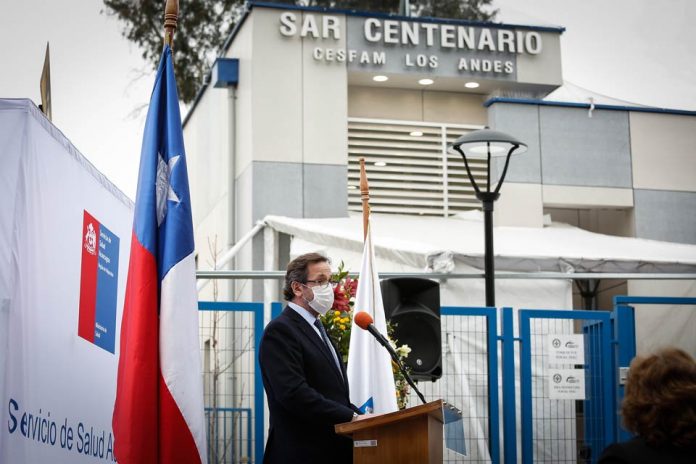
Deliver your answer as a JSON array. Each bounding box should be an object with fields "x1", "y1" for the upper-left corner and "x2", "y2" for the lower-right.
[{"x1": 104, "y1": 0, "x2": 497, "y2": 103}]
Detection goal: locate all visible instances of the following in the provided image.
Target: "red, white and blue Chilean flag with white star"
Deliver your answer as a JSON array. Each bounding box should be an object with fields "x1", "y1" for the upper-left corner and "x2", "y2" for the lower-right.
[{"x1": 112, "y1": 46, "x2": 206, "y2": 464}]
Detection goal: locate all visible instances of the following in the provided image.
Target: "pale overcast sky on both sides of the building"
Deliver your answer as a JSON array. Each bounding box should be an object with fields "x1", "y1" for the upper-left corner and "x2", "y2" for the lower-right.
[{"x1": 0, "y1": 0, "x2": 696, "y2": 198}]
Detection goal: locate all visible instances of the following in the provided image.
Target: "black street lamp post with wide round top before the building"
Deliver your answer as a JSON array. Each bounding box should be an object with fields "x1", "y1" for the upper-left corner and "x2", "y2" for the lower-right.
[{"x1": 449, "y1": 129, "x2": 527, "y2": 307}]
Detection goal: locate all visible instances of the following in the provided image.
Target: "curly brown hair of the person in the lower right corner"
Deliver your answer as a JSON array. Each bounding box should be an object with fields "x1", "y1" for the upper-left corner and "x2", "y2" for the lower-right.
[{"x1": 621, "y1": 348, "x2": 696, "y2": 447}]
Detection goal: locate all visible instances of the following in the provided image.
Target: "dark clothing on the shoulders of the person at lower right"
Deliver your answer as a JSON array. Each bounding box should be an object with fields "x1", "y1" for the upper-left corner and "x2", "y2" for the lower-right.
[{"x1": 599, "y1": 437, "x2": 696, "y2": 464}]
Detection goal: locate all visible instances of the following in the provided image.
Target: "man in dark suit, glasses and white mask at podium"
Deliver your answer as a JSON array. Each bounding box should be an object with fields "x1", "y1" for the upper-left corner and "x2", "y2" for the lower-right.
[{"x1": 259, "y1": 253, "x2": 365, "y2": 464}]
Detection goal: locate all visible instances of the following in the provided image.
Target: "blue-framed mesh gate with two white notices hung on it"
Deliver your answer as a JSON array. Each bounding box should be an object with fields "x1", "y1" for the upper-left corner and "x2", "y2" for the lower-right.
[{"x1": 519, "y1": 309, "x2": 616, "y2": 463}]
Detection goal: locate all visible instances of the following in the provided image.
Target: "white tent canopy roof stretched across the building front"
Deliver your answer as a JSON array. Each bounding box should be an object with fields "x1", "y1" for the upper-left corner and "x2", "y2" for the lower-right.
[{"x1": 265, "y1": 211, "x2": 696, "y2": 273}]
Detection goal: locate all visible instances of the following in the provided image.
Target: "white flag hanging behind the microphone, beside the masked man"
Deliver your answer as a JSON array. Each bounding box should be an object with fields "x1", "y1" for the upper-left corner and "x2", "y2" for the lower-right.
[{"x1": 348, "y1": 222, "x2": 398, "y2": 414}]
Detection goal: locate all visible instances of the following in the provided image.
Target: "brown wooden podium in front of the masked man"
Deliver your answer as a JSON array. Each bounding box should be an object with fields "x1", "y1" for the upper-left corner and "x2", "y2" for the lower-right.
[{"x1": 335, "y1": 400, "x2": 443, "y2": 464}]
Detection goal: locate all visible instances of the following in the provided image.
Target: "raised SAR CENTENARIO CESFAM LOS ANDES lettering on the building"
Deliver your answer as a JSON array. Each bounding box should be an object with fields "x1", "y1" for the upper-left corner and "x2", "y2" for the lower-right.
[{"x1": 278, "y1": 11, "x2": 562, "y2": 82}]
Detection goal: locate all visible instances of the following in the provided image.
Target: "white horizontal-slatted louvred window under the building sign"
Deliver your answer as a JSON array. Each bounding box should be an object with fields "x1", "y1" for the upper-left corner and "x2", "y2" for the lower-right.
[{"x1": 348, "y1": 118, "x2": 486, "y2": 217}]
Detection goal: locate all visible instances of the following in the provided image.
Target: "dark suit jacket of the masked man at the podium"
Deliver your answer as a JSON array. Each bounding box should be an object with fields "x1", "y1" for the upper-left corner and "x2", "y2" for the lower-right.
[{"x1": 259, "y1": 307, "x2": 357, "y2": 464}]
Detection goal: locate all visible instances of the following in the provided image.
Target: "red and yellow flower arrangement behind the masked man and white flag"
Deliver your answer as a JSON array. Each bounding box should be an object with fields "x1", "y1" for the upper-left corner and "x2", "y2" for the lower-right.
[{"x1": 321, "y1": 262, "x2": 411, "y2": 409}]
